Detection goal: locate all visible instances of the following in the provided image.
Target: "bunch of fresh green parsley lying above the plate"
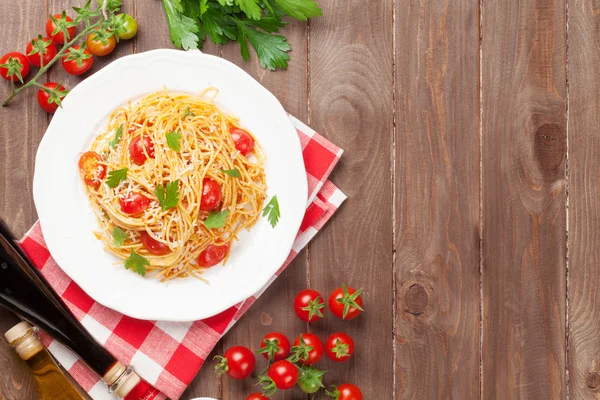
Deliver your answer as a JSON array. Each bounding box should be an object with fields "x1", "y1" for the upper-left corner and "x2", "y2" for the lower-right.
[{"x1": 162, "y1": 0, "x2": 322, "y2": 70}]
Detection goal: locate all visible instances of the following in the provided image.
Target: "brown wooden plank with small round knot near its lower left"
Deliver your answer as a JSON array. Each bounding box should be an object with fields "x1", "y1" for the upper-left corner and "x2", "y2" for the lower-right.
[{"x1": 395, "y1": 0, "x2": 480, "y2": 399}]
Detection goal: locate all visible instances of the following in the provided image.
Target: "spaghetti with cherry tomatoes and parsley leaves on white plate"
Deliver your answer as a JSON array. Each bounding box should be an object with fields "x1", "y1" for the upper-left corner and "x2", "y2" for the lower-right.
[{"x1": 79, "y1": 88, "x2": 266, "y2": 281}]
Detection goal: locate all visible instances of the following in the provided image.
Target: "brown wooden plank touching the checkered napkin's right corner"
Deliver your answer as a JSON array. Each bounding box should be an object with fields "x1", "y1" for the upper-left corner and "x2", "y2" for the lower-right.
[{"x1": 309, "y1": 1, "x2": 394, "y2": 399}]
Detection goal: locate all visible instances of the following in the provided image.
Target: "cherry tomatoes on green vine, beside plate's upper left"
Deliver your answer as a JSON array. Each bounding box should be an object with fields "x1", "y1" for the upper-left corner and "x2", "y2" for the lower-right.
[{"x1": 0, "y1": 0, "x2": 138, "y2": 113}]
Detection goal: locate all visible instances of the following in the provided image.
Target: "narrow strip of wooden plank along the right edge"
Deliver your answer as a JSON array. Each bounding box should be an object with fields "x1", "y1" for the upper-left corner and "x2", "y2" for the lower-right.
[{"x1": 568, "y1": 0, "x2": 600, "y2": 399}]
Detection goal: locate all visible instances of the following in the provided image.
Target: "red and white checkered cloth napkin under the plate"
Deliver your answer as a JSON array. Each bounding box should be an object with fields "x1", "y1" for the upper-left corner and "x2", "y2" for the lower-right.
[{"x1": 21, "y1": 116, "x2": 346, "y2": 400}]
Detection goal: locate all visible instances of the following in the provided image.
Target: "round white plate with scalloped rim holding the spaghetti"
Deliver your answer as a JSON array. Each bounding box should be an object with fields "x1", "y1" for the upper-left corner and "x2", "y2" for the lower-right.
[{"x1": 33, "y1": 50, "x2": 307, "y2": 321}]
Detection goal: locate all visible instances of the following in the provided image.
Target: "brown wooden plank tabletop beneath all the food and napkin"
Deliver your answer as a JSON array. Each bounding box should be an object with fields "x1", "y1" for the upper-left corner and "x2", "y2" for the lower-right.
[{"x1": 0, "y1": 0, "x2": 600, "y2": 400}]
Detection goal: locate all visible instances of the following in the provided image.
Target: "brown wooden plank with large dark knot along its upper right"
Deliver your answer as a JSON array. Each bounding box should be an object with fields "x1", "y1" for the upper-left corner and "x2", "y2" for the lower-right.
[{"x1": 482, "y1": 0, "x2": 566, "y2": 399}]
